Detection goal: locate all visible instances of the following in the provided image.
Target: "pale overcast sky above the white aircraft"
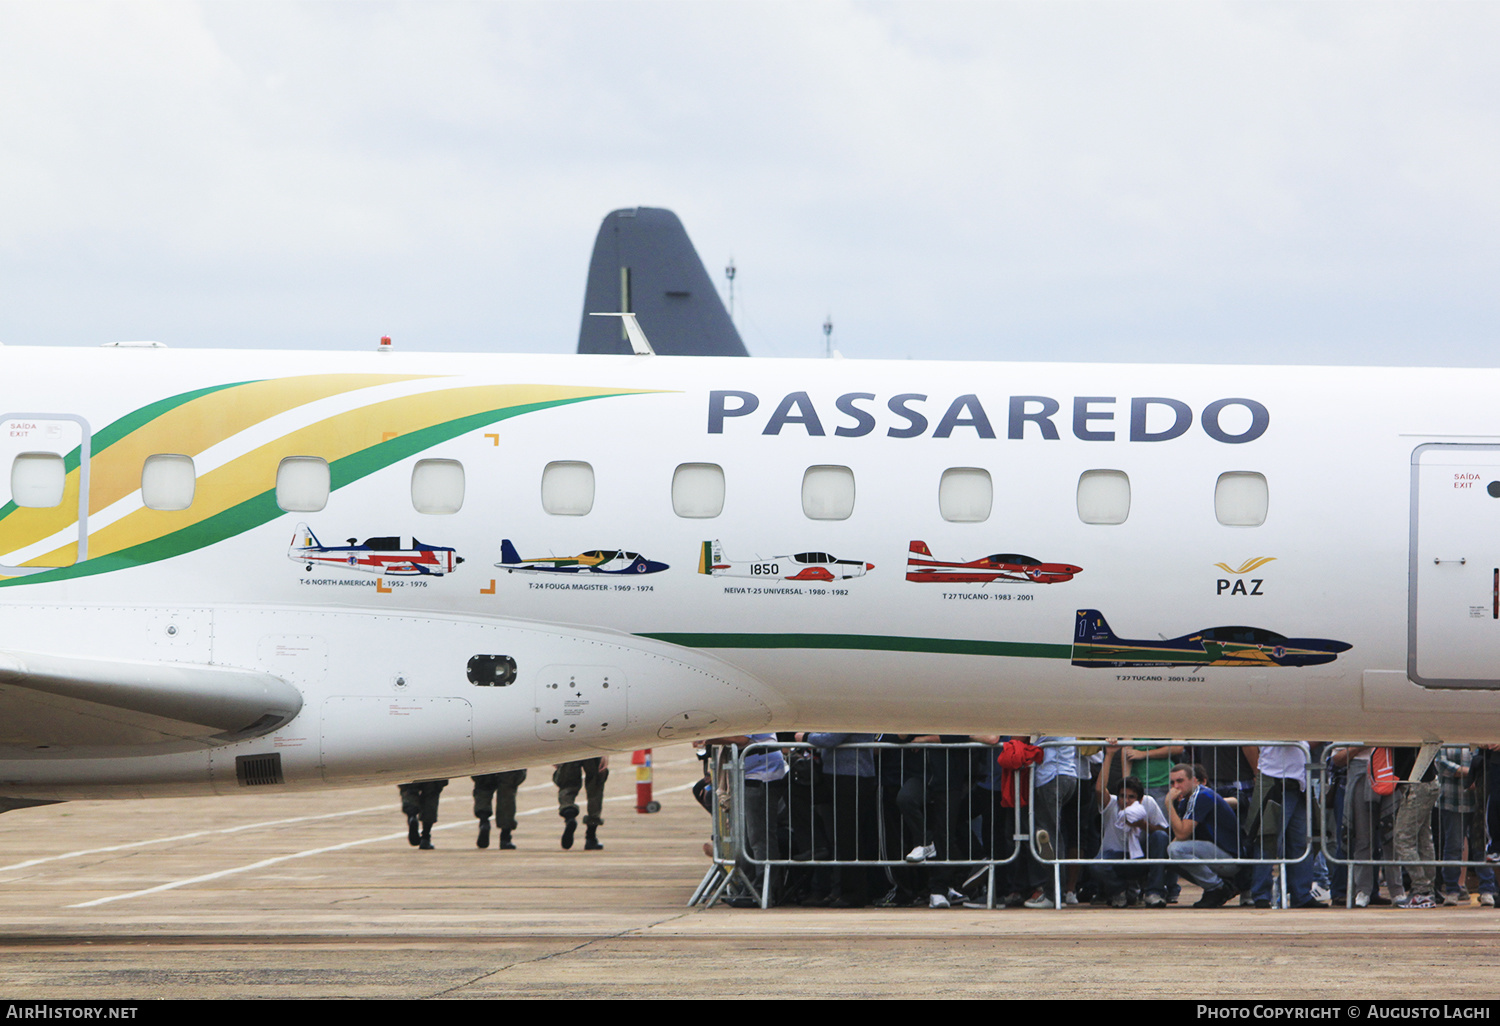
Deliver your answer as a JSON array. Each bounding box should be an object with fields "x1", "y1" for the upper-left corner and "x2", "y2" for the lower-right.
[{"x1": 0, "y1": 0, "x2": 1500, "y2": 366}]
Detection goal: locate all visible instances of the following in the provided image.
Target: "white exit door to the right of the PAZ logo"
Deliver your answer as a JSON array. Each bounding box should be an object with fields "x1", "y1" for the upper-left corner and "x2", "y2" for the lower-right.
[{"x1": 1407, "y1": 444, "x2": 1500, "y2": 689}]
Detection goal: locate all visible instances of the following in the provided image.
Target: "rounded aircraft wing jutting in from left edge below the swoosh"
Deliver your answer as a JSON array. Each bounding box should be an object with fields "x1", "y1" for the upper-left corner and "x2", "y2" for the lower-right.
[{"x1": 0, "y1": 651, "x2": 302, "y2": 758}]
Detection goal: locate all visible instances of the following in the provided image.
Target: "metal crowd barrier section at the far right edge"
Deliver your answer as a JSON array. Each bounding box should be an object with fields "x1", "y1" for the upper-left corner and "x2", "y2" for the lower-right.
[{"x1": 1317, "y1": 741, "x2": 1500, "y2": 908}]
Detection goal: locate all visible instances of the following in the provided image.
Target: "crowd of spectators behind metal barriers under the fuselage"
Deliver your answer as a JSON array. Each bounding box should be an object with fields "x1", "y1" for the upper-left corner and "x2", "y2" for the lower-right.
[{"x1": 701, "y1": 734, "x2": 1500, "y2": 909}]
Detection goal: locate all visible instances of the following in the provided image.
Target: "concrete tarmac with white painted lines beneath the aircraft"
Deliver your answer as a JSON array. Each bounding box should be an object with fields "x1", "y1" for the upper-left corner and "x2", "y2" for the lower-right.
[{"x1": 0, "y1": 746, "x2": 1500, "y2": 1001}]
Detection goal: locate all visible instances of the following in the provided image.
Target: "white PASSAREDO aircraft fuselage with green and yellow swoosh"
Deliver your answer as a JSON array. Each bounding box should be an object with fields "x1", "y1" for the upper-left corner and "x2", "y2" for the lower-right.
[{"x1": 0, "y1": 347, "x2": 1500, "y2": 800}]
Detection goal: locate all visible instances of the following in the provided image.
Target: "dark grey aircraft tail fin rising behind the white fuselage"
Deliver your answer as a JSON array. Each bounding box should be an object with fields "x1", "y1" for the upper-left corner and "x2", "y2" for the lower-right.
[{"x1": 578, "y1": 207, "x2": 750, "y2": 356}]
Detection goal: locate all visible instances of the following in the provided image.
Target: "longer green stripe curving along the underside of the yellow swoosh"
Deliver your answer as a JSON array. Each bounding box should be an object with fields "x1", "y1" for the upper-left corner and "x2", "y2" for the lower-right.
[{"x1": 0, "y1": 396, "x2": 615, "y2": 588}]
